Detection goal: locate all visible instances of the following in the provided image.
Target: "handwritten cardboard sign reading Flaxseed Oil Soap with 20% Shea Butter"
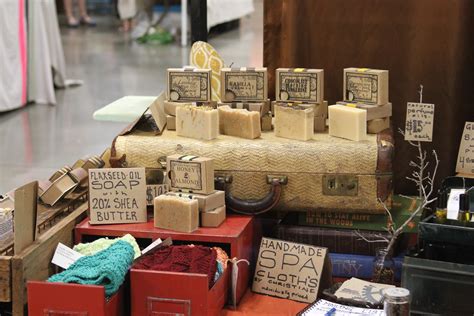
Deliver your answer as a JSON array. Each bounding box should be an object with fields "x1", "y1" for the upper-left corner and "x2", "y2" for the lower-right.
[{"x1": 89, "y1": 168, "x2": 147, "y2": 224}]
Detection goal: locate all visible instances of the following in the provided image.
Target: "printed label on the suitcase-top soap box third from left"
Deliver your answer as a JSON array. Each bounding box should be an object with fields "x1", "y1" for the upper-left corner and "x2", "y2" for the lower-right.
[{"x1": 278, "y1": 72, "x2": 318, "y2": 101}]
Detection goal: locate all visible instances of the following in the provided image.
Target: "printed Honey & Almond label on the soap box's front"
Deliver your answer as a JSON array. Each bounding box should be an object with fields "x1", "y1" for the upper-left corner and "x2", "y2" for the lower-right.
[{"x1": 170, "y1": 160, "x2": 203, "y2": 191}]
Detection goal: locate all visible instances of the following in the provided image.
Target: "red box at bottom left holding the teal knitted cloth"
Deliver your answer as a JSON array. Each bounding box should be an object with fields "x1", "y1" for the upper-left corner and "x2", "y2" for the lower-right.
[{"x1": 28, "y1": 281, "x2": 125, "y2": 316}]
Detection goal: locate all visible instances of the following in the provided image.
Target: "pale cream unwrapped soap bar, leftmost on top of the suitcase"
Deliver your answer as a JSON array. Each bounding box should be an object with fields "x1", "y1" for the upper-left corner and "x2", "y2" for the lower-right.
[{"x1": 176, "y1": 106, "x2": 219, "y2": 140}]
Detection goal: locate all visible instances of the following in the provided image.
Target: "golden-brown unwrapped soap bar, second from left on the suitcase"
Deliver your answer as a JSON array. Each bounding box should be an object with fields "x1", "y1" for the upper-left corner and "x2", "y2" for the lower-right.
[{"x1": 218, "y1": 105, "x2": 261, "y2": 139}]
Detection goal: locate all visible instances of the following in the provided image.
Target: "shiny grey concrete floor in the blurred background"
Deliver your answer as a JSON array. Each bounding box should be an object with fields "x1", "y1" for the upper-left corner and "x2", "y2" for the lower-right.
[{"x1": 0, "y1": 1, "x2": 263, "y2": 194}]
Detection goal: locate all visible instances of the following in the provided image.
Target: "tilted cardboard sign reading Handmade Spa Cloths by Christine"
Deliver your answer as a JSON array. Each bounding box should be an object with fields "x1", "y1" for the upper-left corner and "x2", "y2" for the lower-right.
[{"x1": 252, "y1": 238, "x2": 327, "y2": 303}]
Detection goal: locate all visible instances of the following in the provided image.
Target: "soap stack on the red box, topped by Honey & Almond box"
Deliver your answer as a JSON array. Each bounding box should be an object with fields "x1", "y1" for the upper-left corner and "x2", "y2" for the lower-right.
[{"x1": 154, "y1": 155, "x2": 226, "y2": 232}]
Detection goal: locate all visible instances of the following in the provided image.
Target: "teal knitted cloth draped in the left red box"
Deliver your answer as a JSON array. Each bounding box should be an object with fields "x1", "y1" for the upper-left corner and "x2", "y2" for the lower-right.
[{"x1": 48, "y1": 240, "x2": 135, "y2": 296}]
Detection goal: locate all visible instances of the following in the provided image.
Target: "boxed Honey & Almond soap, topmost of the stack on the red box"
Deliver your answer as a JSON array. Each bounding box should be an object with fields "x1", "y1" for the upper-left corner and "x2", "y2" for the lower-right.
[{"x1": 166, "y1": 155, "x2": 214, "y2": 194}]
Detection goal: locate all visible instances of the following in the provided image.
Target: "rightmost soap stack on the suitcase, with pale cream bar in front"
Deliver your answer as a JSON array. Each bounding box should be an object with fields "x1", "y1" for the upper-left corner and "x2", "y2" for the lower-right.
[{"x1": 329, "y1": 68, "x2": 392, "y2": 141}]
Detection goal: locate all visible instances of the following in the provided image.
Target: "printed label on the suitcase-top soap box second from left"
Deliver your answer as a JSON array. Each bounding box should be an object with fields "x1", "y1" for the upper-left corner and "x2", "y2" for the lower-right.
[{"x1": 224, "y1": 71, "x2": 265, "y2": 101}]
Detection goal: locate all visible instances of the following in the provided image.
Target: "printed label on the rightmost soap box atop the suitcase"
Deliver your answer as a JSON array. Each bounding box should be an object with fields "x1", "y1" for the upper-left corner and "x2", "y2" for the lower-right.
[{"x1": 345, "y1": 72, "x2": 379, "y2": 104}]
